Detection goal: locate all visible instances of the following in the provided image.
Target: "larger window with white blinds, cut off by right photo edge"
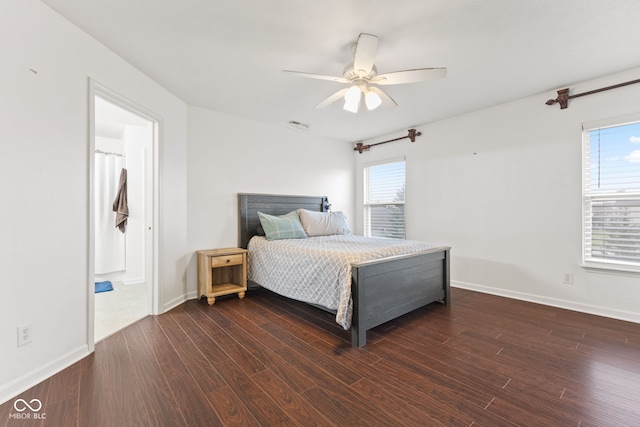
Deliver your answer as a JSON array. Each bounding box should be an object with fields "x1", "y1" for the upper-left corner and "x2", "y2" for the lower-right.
[{"x1": 583, "y1": 117, "x2": 640, "y2": 270}]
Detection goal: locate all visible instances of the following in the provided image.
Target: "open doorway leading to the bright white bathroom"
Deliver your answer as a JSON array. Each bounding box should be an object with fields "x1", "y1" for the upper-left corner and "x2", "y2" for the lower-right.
[{"x1": 89, "y1": 83, "x2": 158, "y2": 343}]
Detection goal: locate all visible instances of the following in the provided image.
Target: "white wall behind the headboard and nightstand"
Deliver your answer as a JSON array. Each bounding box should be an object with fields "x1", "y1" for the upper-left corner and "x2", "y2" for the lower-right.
[{"x1": 187, "y1": 106, "x2": 354, "y2": 298}]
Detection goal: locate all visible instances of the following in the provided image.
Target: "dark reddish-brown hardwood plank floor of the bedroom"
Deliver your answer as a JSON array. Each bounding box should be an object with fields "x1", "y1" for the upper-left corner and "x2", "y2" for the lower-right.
[{"x1": 0, "y1": 289, "x2": 640, "y2": 427}]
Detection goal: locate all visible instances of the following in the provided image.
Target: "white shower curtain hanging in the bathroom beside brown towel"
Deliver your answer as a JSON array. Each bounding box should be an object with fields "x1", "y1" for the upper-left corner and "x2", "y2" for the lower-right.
[{"x1": 94, "y1": 153, "x2": 126, "y2": 274}]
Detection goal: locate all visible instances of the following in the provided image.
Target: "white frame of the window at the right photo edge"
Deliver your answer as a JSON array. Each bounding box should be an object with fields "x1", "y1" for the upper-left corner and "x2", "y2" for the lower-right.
[{"x1": 582, "y1": 114, "x2": 640, "y2": 273}]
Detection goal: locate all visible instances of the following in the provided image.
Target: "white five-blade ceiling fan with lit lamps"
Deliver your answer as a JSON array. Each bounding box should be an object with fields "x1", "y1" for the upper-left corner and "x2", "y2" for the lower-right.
[{"x1": 282, "y1": 33, "x2": 447, "y2": 113}]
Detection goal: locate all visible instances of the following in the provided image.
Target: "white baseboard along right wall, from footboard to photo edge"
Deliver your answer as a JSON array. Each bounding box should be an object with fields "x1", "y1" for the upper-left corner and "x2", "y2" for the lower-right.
[{"x1": 451, "y1": 280, "x2": 640, "y2": 323}]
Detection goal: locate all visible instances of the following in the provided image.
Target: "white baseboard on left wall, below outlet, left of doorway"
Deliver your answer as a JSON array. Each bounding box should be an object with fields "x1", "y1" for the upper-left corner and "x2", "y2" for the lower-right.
[{"x1": 0, "y1": 345, "x2": 90, "y2": 404}]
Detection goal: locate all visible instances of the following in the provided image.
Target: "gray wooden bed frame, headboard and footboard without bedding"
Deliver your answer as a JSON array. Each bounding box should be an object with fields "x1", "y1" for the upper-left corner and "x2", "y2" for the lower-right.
[{"x1": 238, "y1": 193, "x2": 451, "y2": 347}]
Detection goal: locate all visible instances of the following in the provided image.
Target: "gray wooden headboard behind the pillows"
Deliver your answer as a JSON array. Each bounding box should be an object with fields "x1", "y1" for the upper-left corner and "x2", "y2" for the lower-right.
[{"x1": 238, "y1": 193, "x2": 329, "y2": 249}]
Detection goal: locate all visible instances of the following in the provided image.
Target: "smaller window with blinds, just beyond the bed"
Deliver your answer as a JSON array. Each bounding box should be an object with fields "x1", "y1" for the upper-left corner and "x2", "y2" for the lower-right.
[{"x1": 364, "y1": 160, "x2": 405, "y2": 239}]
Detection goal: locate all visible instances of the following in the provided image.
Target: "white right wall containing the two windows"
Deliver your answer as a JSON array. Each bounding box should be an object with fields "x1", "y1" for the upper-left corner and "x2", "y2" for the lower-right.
[{"x1": 356, "y1": 70, "x2": 640, "y2": 322}]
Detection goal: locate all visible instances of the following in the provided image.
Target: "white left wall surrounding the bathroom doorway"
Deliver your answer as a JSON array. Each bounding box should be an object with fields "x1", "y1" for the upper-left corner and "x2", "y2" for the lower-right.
[{"x1": 0, "y1": 0, "x2": 187, "y2": 402}]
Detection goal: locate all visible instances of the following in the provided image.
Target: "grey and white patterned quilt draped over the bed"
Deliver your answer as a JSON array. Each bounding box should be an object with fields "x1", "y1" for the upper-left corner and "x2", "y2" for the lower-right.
[{"x1": 247, "y1": 235, "x2": 434, "y2": 329}]
